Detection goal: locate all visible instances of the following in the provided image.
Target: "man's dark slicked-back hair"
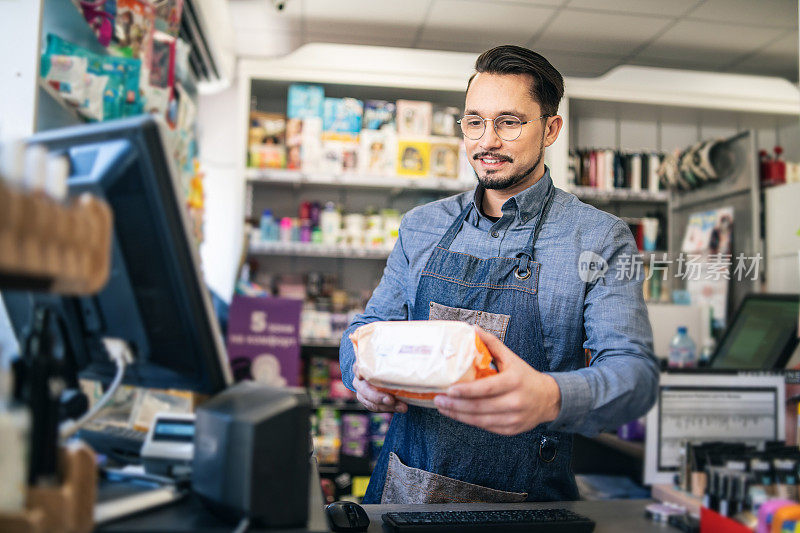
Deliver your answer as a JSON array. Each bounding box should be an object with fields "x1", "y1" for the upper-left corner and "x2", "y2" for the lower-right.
[{"x1": 467, "y1": 44, "x2": 564, "y2": 116}]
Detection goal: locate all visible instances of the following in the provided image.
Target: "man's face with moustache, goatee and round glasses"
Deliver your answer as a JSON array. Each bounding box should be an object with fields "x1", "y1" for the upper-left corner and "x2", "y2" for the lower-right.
[{"x1": 464, "y1": 72, "x2": 552, "y2": 189}]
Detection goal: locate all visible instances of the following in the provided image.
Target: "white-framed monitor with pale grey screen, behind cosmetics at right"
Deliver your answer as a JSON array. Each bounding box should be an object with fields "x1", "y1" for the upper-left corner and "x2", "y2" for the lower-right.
[{"x1": 644, "y1": 373, "x2": 786, "y2": 485}]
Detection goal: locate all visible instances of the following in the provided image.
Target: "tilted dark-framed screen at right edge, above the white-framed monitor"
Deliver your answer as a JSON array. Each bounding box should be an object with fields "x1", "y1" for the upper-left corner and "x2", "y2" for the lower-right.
[{"x1": 710, "y1": 294, "x2": 800, "y2": 370}]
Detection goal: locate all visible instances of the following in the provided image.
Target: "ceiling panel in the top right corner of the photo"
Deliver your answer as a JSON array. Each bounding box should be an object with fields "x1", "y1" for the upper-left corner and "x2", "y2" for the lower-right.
[{"x1": 690, "y1": 0, "x2": 797, "y2": 28}]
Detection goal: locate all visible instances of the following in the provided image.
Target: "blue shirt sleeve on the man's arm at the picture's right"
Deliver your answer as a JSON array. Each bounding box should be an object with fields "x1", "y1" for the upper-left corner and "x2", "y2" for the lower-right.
[{"x1": 549, "y1": 221, "x2": 659, "y2": 436}]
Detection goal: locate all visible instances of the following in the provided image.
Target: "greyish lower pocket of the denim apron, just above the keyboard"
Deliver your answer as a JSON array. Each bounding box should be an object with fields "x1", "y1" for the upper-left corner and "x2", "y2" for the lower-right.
[{"x1": 381, "y1": 452, "x2": 528, "y2": 504}]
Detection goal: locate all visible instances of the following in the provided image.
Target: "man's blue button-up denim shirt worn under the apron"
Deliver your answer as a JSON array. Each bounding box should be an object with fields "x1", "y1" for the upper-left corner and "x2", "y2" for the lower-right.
[{"x1": 339, "y1": 169, "x2": 659, "y2": 435}]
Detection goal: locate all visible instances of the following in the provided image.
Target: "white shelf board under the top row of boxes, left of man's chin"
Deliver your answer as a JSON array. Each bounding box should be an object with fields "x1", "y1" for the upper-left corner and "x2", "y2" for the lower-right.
[{"x1": 245, "y1": 168, "x2": 474, "y2": 192}]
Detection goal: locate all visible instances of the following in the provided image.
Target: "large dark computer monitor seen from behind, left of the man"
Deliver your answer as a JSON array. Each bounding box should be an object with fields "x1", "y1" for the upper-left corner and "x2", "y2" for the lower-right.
[{"x1": 3, "y1": 116, "x2": 232, "y2": 394}]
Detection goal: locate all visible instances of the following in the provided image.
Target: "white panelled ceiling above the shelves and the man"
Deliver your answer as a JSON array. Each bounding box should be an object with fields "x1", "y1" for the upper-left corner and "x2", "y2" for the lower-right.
[{"x1": 229, "y1": 0, "x2": 798, "y2": 81}]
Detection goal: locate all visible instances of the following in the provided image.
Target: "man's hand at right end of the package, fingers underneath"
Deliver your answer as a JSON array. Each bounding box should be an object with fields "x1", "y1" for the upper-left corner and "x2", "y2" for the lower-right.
[{"x1": 434, "y1": 328, "x2": 561, "y2": 435}]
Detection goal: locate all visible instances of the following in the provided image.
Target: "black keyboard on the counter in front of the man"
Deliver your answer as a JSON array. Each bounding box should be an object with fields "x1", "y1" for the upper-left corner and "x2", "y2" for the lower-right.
[{"x1": 381, "y1": 509, "x2": 594, "y2": 533}]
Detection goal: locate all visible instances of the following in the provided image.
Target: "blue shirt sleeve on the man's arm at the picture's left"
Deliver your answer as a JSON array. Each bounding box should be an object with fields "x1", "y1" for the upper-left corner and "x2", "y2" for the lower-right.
[{"x1": 339, "y1": 218, "x2": 409, "y2": 391}]
